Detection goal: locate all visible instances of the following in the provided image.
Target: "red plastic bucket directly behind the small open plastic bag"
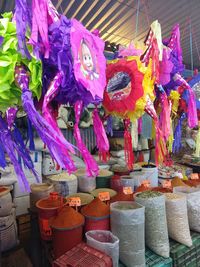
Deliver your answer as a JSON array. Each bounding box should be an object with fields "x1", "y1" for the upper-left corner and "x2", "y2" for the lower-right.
[{"x1": 84, "y1": 215, "x2": 110, "y2": 233}]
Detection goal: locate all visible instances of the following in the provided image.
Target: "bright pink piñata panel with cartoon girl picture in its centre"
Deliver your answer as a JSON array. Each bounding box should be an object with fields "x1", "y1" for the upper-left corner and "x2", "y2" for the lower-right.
[{"x1": 70, "y1": 19, "x2": 106, "y2": 99}]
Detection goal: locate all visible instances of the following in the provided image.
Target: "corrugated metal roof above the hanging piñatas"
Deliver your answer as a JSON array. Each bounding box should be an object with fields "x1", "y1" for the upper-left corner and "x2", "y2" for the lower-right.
[{"x1": 0, "y1": 0, "x2": 200, "y2": 69}]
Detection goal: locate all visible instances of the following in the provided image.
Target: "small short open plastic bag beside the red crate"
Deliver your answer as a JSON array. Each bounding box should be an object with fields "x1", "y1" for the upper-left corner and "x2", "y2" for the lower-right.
[{"x1": 85, "y1": 230, "x2": 119, "y2": 267}]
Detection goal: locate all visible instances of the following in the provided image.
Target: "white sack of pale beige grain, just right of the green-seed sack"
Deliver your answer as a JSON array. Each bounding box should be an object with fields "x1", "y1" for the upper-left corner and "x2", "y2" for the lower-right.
[{"x1": 165, "y1": 193, "x2": 192, "y2": 247}]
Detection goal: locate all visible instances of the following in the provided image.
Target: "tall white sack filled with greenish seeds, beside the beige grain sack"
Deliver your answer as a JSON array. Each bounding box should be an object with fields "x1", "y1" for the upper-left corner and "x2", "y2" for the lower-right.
[{"x1": 135, "y1": 192, "x2": 169, "y2": 258}]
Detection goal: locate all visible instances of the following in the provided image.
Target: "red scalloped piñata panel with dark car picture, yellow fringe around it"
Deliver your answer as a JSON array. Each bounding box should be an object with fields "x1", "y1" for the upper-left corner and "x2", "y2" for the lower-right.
[{"x1": 103, "y1": 59, "x2": 144, "y2": 118}]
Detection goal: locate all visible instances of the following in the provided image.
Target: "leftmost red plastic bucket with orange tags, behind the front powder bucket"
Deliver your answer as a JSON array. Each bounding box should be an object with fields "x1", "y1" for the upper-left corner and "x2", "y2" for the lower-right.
[{"x1": 36, "y1": 192, "x2": 63, "y2": 240}]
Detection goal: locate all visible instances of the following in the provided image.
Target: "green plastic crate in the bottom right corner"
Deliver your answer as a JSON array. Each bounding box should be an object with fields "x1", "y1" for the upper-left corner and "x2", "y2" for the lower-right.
[{"x1": 170, "y1": 232, "x2": 200, "y2": 267}]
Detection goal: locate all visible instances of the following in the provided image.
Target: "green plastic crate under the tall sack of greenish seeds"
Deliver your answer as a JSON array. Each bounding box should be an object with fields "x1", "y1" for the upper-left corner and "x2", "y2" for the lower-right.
[{"x1": 119, "y1": 248, "x2": 173, "y2": 267}]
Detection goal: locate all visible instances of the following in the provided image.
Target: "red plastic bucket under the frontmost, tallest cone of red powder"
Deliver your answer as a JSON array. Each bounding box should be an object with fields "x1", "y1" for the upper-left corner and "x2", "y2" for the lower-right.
[{"x1": 52, "y1": 225, "x2": 83, "y2": 259}]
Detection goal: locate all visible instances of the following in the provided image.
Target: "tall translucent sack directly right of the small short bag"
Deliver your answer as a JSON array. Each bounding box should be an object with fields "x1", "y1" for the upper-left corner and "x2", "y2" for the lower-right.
[{"x1": 110, "y1": 201, "x2": 145, "y2": 267}]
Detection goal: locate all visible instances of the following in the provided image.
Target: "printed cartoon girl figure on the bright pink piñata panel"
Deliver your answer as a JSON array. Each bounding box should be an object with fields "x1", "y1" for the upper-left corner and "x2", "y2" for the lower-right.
[{"x1": 79, "y1": 39, "x2": 99, "y2": 80}]
